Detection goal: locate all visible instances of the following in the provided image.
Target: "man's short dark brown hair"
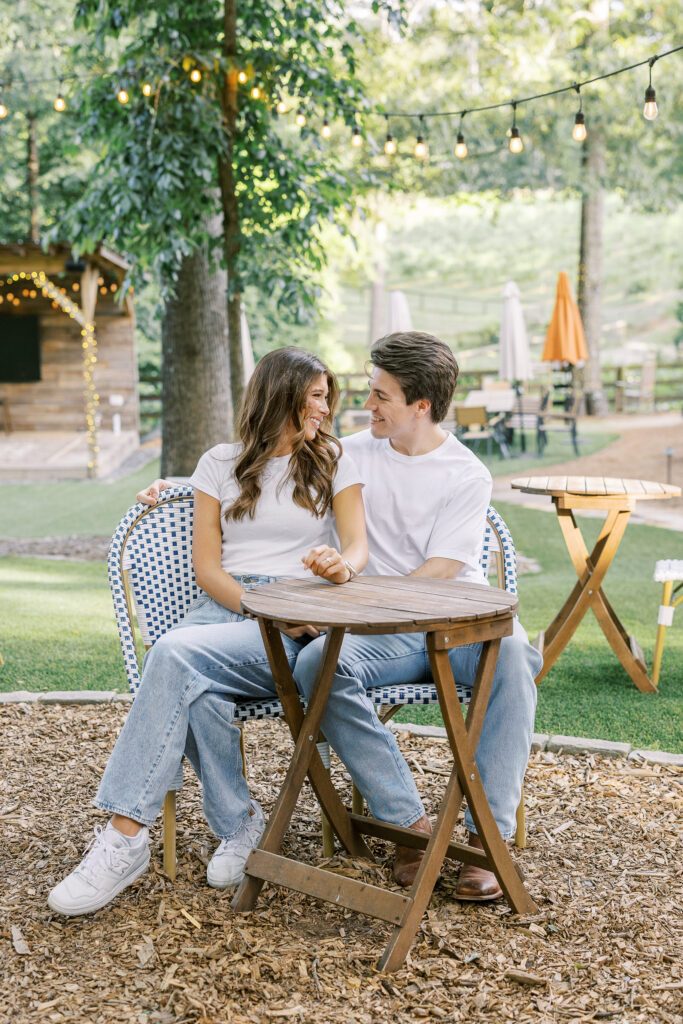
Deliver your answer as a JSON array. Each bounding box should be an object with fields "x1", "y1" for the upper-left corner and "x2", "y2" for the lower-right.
[{"x1": 370, "y1": 331, "x2": 458, "y2": 423}]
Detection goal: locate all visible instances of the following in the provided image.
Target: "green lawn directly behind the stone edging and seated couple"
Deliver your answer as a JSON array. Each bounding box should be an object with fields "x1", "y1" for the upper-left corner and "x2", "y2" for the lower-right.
[{"x1": 0, "y1": 501, "x2": 683, "y2": 753}]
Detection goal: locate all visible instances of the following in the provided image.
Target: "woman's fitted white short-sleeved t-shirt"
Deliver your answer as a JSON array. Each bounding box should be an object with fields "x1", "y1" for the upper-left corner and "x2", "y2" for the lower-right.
[{"x1": 189, "y1": 444, "x2": 362, "y2": 579}]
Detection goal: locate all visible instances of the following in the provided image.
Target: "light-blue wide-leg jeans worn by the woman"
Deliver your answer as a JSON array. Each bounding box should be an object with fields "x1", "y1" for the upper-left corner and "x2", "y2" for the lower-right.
[{"x1": 94, "y1": 577, "x2": 302, "y2": 839}]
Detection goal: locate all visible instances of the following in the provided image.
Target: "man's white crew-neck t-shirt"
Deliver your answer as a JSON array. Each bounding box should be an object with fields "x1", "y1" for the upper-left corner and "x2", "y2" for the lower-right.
[{"x1": 343, "y1": 430, "x2": 492, "y2": 583}]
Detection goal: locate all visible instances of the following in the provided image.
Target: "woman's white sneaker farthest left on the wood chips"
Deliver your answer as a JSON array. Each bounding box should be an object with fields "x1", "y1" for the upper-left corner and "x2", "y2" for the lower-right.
[{"x1": 47, "y1": 821, "x2": 150, "y2": 918}]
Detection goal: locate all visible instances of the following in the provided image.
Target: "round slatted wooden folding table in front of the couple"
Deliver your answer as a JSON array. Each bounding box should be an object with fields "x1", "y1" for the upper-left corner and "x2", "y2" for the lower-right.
[{"x1": 232, "y1": 577, "x2": 537, "y2": 971}]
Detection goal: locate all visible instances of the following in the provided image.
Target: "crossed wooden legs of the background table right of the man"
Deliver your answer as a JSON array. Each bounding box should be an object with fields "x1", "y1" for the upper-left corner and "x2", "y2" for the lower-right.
[{"x1": 537, "y1": 502, "x2": 656, "y2": 693}]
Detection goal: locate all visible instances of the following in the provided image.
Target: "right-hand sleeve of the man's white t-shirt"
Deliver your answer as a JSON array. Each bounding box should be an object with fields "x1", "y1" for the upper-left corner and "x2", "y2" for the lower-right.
[{"x1": 425, "y1": 474, "x2": 492, "y2": 568}]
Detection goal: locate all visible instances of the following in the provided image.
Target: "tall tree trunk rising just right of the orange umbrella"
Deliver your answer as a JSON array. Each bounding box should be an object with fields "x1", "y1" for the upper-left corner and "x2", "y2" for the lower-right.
[{"x1": 578, "y1": 135, "x2": 608, "y2": 416}]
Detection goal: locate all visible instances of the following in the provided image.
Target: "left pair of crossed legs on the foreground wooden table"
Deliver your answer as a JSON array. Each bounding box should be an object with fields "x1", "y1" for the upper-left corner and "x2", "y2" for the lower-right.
[{"x1": 232, "y1": 620, "x2": 373, "y2": 911}]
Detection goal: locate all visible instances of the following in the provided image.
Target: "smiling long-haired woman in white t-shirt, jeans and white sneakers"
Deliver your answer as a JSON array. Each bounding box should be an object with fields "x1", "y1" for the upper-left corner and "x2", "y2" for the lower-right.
[{"x1": 48, "y1": 348, "x2": 368, "y2": 916}]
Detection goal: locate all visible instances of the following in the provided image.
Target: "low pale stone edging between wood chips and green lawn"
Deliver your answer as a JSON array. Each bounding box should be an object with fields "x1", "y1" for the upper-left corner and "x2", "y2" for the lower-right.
[{"x1": 0, "y1": 690, "x2": 683, "y2": 768}]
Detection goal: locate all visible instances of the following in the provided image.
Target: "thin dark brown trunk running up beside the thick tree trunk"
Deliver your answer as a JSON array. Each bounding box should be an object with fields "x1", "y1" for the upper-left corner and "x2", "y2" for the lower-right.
[{"x1": 218, "y1": 0, "x2": 244, "y2": 410}]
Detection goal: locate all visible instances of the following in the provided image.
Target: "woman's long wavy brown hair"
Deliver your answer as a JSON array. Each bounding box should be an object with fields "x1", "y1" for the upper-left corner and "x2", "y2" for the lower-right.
[{"x1": 225, "y1": 348, "x2": 341, "y2": 521}]
